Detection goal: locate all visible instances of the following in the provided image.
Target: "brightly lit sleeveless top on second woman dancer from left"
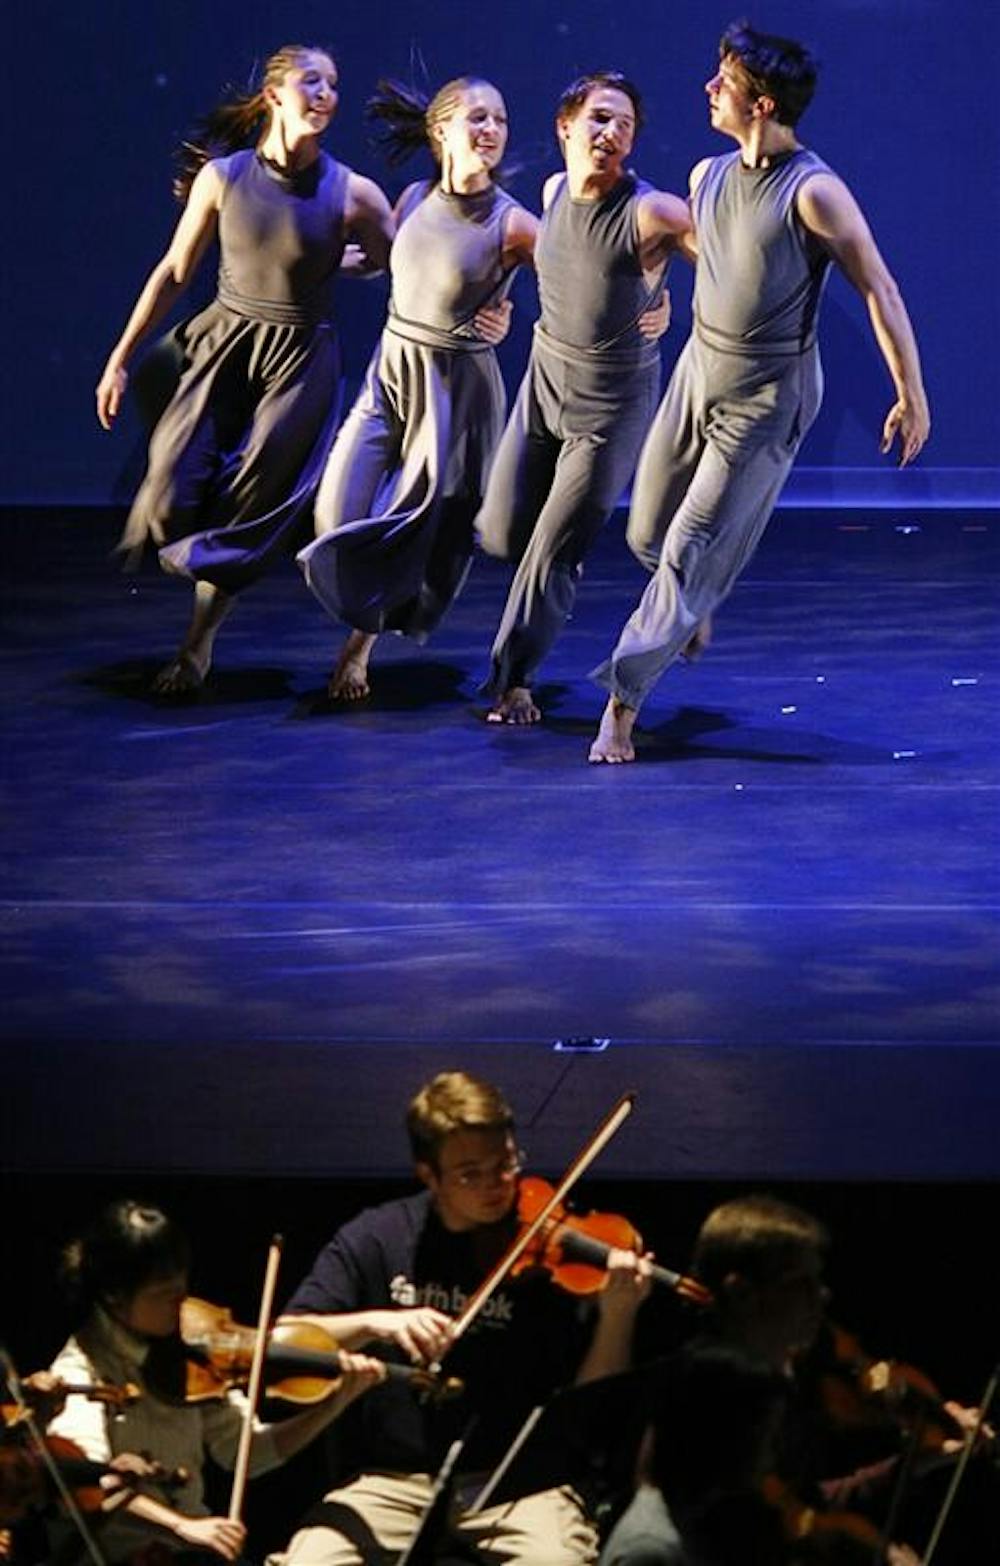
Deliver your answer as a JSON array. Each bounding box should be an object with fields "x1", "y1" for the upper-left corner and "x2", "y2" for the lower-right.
[{"x1": 388, "y1": 182, "x2": 516, "y2": 352}]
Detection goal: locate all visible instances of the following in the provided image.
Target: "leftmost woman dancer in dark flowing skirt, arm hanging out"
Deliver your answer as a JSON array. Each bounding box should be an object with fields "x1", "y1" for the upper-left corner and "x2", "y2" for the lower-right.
[{"x1": 97, "y1": 45, "x2": 391, "y2": 694}]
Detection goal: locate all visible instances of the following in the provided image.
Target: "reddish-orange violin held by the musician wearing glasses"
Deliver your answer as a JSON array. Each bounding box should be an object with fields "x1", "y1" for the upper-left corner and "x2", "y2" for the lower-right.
[{"x1": 510, "y1": 1175, "x2": 712, "y2": 1304}]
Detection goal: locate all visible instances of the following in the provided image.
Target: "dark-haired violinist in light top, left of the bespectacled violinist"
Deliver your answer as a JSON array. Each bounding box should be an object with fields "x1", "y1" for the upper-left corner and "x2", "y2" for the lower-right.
[{"x1": 49, "y1": 1200, "x2": 383, "y2": 1561}]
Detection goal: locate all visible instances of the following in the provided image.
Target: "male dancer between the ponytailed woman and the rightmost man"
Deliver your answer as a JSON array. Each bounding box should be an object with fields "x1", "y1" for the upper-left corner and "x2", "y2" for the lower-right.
[{"x1": 477, "y1": 72, "x2": 689, "y2": 723}]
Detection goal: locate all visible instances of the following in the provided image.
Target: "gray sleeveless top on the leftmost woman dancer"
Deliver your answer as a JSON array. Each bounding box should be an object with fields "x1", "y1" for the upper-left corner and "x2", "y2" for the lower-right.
[{"x1": 218, "y1": 149, "x2": 347, "y2": 326}]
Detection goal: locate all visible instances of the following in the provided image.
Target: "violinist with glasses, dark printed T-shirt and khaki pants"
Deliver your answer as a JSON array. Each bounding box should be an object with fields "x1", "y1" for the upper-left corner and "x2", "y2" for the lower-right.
[{"x1": 278, "y1": 1071, "x2": 649, "y2": 1566}]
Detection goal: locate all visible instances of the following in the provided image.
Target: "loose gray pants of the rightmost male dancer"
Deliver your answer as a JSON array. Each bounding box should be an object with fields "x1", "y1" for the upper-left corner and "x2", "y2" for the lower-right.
[{"x1": 592, "y1": 337, "x2": 823, "y2": 708}]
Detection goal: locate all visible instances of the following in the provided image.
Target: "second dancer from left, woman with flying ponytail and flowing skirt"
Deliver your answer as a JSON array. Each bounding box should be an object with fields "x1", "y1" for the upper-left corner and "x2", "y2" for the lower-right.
[{"x1": 299, "y1": 77, "x2": 537, "y2": 700}]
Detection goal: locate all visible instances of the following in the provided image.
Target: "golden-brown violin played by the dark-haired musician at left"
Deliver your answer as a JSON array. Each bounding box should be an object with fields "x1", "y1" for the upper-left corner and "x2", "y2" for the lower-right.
[{"x1": 146, "y1": 1297, "x2": 465, "y2": 1403}]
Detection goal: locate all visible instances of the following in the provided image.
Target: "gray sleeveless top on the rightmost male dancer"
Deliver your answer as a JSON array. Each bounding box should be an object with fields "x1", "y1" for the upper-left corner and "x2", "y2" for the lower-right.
[{"x1": 695, "y1": 147, "x2": 829, "y2": 354}]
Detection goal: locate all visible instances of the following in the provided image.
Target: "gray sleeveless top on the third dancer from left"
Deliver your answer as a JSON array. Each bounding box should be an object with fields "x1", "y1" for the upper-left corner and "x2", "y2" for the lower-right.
[{"x1": 535, "y1": 174, "x2": 662, "y2": 368}]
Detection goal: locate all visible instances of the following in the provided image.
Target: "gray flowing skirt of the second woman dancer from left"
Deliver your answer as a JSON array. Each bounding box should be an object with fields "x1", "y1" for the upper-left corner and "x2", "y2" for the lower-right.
[{"x1": 297, "y1": 327, "x2": 505, "y2": 642}]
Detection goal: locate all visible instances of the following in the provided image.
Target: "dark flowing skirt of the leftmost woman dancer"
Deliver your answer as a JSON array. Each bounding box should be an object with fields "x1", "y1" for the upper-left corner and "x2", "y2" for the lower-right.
[{"x1": 121, "y1": 301, "x2": 341, "y2": 592}]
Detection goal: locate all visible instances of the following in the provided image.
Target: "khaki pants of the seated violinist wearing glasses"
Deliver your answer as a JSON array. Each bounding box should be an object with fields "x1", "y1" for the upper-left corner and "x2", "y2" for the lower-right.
[{"x1": 271, "y1": 1474, "x2": 598, "y2": 1566}]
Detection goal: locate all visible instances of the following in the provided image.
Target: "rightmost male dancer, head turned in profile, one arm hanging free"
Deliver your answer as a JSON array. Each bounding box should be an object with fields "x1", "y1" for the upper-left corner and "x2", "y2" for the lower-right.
[{"x1": 590, "y1": 23, "x2": 930, "y2": 761}]
